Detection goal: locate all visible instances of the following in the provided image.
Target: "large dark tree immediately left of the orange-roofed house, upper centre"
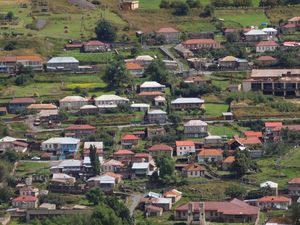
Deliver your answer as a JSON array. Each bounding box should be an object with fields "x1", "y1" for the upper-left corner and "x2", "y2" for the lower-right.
[{"x1": 103, "y1": 60, "x2": 130, "y2": 88}]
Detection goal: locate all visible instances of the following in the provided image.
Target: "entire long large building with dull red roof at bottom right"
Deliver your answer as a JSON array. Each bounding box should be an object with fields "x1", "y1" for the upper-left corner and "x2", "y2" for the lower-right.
[{"x1": 174, "y1": 199, "x2": 260, "y2": 224}]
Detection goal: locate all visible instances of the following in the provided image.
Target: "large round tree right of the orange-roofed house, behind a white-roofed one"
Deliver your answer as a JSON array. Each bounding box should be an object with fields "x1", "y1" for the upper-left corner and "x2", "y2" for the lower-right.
[{"x1": 145, "y1": 59, "x2": 169, "y2": 83}]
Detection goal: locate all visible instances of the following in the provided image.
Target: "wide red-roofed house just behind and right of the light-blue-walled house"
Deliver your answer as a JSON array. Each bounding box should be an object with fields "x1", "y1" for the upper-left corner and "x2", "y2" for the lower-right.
[{"x1": 64, "y1": 124, "x2": 96, "y2": 138}]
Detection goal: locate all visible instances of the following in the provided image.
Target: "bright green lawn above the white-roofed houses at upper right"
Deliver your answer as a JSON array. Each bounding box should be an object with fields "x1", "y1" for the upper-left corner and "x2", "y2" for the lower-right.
[{"x1": 215, "y1": 9, "x2": 269, "y2": 28}]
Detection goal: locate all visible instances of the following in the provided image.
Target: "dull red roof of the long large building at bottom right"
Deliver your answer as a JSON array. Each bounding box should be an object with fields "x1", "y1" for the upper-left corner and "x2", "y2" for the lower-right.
[{"x1": 176, "y1": 199, "x2": 259, "y2": 216}]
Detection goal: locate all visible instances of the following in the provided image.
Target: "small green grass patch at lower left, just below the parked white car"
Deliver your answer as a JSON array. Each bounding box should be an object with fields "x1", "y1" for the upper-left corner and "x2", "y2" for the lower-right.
[{"x1": 16, "y1": 161, "x2": 50, "y2": 177}]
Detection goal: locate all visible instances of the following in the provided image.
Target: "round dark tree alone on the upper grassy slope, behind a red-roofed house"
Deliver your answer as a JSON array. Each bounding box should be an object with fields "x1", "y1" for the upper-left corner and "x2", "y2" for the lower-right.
[{"x1": 95, "y1": 19, "x2": 117, "y2": 42}]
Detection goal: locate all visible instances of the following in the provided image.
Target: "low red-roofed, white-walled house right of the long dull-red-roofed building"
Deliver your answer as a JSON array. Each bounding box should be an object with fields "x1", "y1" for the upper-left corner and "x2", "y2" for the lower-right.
[{"x1": 257, "y1": 195, "x2": 292, "y2": 210}]
